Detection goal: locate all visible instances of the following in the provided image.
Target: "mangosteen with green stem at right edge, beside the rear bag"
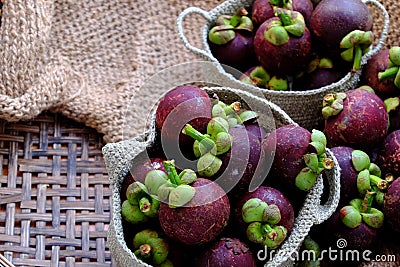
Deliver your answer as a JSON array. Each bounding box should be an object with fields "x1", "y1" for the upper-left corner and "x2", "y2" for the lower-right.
[{"x1": 361, "y1": 48, "x2": 400, "y2": 98}]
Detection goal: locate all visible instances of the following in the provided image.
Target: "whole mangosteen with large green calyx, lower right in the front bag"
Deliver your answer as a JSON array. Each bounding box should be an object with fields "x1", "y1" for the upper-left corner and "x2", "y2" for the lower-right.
[{"x1": 233, "y1": 186, "x2": 294, "y2": 249}]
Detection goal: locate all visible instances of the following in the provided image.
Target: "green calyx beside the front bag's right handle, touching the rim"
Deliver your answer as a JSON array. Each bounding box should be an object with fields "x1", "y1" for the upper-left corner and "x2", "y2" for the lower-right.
[{"x1": 295, "y1": 129, "x2": 334, "y2": 191}]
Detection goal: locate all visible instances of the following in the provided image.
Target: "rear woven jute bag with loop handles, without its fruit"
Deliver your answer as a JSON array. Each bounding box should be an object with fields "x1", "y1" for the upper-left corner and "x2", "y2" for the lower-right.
[{"x1": 177, "y1": 0, "x2": 390, "y2": 129}]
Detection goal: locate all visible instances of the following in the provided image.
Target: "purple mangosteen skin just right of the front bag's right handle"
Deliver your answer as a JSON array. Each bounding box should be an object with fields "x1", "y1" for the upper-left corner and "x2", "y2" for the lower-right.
[{"x1": 331, "y1": 146, "x2": 359, "y2": 207}]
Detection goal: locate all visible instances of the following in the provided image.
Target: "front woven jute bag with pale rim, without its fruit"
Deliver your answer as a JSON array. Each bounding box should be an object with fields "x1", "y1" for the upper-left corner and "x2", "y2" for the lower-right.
[{"x1": 103, "y1": 87, "x2": 340, "y2": 266}]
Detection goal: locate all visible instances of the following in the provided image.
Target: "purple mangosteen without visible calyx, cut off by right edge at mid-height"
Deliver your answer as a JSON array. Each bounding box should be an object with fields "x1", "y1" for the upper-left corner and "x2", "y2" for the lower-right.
[{"x1": 378, "y1": 130, "x2": 400, "y2": 178}]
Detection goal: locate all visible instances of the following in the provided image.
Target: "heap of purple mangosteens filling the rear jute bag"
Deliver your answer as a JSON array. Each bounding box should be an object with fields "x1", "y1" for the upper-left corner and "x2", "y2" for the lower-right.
[{"x1": 208, "y1": 0, "x2": 374, "y2": 90}]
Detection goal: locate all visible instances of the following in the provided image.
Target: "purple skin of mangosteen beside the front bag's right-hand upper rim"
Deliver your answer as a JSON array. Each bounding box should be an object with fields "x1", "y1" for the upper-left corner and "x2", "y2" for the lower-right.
[{"x1": 262, "y1": 125, "x2": 311, "y2": 191}]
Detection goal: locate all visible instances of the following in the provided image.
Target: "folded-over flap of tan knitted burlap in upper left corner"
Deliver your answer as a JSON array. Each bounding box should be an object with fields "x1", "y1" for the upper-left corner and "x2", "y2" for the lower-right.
[{"x1": 0, "y1": 0, "x2": 83, "y2": 121}]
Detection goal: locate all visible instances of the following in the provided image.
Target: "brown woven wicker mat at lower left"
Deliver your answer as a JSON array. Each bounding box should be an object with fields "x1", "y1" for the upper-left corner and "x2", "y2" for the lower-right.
[{"x1": 0, "y1": 113, "x2": 111, "y2": 266}]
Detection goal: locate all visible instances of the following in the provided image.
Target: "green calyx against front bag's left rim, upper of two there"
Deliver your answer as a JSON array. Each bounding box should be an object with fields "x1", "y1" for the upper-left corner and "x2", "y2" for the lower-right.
[{"x1": 121, "y1": 181, "x2": 160, "y2": 224}]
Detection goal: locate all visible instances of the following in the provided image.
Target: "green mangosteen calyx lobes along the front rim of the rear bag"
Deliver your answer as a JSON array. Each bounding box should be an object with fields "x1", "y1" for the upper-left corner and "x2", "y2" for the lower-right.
[{"x1": 239, "y1": 66, "x2": 289, "y2": 91}]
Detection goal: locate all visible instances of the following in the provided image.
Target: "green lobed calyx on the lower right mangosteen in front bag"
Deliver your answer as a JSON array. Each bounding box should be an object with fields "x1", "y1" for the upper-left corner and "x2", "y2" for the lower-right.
[{"x1": 242, "y1": 198, "x2": 287, "y2": 249}]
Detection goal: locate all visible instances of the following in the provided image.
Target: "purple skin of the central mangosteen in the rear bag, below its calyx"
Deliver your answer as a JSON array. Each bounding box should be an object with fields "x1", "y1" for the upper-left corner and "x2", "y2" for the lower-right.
[{"x1": 254, "y1": 17, "x2": 312, "y2": 75}]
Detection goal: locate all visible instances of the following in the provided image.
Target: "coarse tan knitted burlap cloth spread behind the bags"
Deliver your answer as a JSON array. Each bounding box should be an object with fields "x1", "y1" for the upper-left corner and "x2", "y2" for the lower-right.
[{"x1": 0, "y1": 0, "x2": 400, "y2": 142}]
